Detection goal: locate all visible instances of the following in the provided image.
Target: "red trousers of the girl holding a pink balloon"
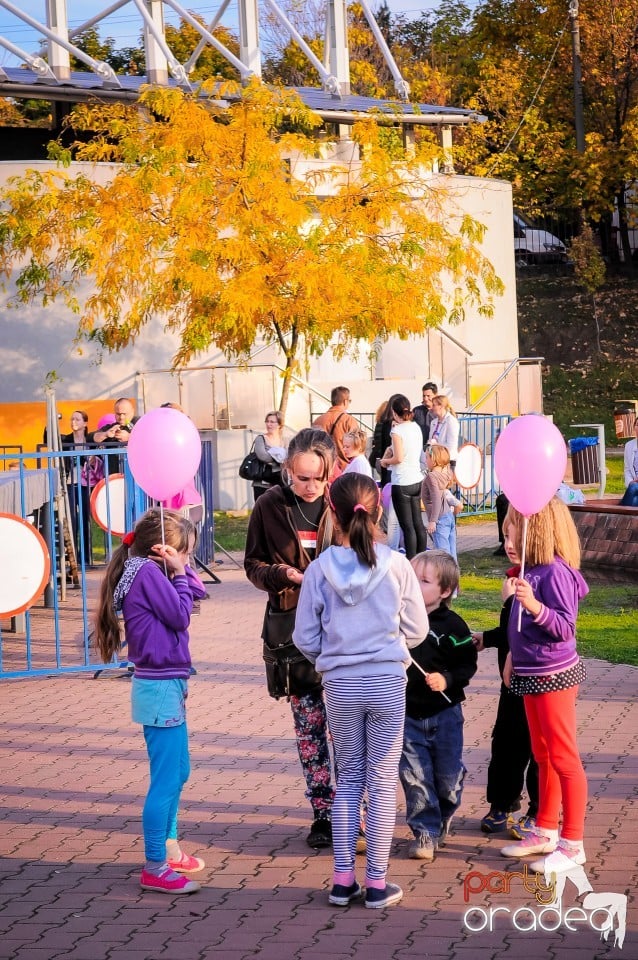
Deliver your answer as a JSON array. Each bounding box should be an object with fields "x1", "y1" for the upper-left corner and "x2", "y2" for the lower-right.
[{"x1": 523, "y1": 687, "x2": 587, "y2": 840}]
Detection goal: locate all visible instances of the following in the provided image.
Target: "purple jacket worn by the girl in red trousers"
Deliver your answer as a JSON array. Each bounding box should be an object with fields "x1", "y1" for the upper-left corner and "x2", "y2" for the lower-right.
[{"x1": 507, "y1": 557, "x2": 589, "y2": 677}]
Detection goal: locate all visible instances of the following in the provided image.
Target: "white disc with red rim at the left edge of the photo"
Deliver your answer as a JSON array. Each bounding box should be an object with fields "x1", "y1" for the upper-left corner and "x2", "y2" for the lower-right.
[{"x1": 0, "y1": 513, "x2": 51, "y2": 618}]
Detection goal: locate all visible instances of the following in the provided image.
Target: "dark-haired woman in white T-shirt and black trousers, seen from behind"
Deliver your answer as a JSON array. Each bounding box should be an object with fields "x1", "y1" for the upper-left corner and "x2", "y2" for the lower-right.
[{"x1": 381, "y1": 393, "x2": 427, "y2": 560}]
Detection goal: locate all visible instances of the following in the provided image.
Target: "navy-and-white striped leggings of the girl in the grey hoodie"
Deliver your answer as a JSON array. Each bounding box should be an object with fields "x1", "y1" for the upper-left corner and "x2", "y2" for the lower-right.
[{"x1": 324, "y1": 676, "x2": 406, "y2": 881}]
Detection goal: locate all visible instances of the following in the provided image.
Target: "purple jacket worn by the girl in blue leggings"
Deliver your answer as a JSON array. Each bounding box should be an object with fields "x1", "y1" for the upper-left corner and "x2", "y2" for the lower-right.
[{"x1": 118, "y1": 558, "x2": 194, "y2": 680}]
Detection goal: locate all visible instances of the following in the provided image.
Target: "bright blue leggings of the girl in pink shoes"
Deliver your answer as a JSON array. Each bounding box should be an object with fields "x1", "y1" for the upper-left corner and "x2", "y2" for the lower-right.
[{"x1": 142, "y1": 723, "x2": 190, "y2": 862}]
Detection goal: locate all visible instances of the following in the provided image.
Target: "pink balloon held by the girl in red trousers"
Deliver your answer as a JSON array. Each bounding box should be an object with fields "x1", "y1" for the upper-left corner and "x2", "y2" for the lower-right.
[{"x1": 494, "y1": 413, "x2": 567, "y2": 517}]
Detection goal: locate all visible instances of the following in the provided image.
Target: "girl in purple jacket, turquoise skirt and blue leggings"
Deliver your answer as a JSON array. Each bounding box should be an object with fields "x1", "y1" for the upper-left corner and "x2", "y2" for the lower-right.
[{"x1": 96, "y1": 510, "x2": 205, "y2": 894}]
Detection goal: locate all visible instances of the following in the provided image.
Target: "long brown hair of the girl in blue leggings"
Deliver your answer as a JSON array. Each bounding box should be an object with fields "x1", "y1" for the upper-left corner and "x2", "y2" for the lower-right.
[{"x1": 95, "y1": 508, "x2": 197, "y2": 663}]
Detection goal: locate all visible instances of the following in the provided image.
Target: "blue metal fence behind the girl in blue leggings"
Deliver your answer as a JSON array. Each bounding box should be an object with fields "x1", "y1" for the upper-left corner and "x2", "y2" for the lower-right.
[{"x1": 0, "y1": 440, "x2": 215, "y2": 679}]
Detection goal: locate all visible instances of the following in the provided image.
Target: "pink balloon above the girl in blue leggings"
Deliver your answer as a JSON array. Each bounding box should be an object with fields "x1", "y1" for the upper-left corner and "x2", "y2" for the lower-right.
[{"x1": 127, "y1": 407, "x2": 202, "y2": 500}]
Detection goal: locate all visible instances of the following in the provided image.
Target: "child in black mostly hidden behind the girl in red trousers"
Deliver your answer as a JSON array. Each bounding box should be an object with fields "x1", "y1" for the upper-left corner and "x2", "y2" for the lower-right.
[{"x1": 472, "y1": 525, "x2": 538, "y2": 840}]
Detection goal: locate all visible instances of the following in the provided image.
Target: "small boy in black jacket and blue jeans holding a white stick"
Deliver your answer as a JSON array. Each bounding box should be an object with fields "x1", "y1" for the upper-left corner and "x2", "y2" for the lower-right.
[{"x1": 399, "y1": 550, "x2": 477, "y2": 860}]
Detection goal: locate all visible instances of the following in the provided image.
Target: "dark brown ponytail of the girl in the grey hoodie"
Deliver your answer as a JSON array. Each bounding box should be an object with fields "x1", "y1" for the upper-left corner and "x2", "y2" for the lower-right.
[{"x1": 329, "y1": 473, "x2": 380, "y2": 567}]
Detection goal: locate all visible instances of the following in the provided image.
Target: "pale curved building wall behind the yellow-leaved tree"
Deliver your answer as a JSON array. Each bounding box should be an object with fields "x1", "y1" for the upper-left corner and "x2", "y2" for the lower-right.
[{"x1": 0, "y1": 161, "x2": 518, "y2": 429}]
